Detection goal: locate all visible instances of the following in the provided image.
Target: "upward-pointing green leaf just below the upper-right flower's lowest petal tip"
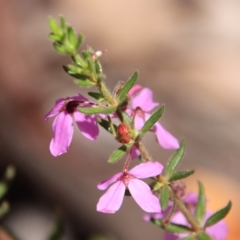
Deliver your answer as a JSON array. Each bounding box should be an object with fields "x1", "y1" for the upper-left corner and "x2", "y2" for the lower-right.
[{"x1": 166, "y1": 141, "x2": 185, "y2": 178}]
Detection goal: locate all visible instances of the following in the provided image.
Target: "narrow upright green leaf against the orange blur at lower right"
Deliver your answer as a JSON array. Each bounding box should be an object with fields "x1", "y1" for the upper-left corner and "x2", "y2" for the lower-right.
[{"x1": 194, "y1": 182, "x2": 206, "y2": 224}]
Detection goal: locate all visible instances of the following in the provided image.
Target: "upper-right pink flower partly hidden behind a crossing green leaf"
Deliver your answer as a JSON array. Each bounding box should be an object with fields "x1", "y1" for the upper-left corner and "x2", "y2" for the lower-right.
[{"x1": 128, "y1": 85, "x2": 179, "y2": 149}]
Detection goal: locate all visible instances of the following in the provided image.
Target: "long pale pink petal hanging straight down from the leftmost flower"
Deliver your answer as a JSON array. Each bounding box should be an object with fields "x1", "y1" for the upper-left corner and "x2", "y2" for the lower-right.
[{"x1": 50, "y1": 112, "x2": 73, "y2": 157}]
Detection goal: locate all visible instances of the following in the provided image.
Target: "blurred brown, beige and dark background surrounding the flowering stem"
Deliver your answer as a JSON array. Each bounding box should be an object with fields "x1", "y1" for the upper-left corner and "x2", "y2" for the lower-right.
[{"x1": 0, "y1": 0, "x2": 240, "y2": 240}]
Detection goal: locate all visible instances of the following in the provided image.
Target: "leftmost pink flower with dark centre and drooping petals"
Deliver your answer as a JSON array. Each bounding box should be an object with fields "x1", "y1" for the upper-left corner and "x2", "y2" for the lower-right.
[{"x1": 45, "y1": 94, "x2": 99, "y2": 157}]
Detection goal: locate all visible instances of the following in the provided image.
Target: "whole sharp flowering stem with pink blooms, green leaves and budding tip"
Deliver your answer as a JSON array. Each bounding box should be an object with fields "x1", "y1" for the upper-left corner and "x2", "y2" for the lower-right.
[{"x1": 45, "y1": 18, "x2": 231, "y2": 240}]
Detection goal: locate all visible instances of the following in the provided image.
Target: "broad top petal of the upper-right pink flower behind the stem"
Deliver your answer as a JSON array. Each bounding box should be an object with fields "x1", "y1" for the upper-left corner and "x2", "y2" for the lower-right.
[{"x1": 132, "y1": 88, "x2": 159, "y2": 112}]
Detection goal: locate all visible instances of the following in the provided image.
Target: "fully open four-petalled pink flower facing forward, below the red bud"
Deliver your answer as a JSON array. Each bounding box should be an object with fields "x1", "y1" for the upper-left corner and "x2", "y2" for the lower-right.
[{"x1": 97, "y1": 162, "x2": 163, "y2": 213}]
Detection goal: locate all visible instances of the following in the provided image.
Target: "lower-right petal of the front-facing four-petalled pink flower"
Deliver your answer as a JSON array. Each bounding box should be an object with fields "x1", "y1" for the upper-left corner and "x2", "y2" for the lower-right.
[{"x1": 128, "y1": 179, "x2": 161, "y2": 213}]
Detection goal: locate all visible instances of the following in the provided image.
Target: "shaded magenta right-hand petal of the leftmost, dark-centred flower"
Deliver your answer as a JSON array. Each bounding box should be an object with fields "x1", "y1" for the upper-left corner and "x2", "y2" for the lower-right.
[{"x1": 73, "y1": 111, "x2": 99, "y2": 140}]
